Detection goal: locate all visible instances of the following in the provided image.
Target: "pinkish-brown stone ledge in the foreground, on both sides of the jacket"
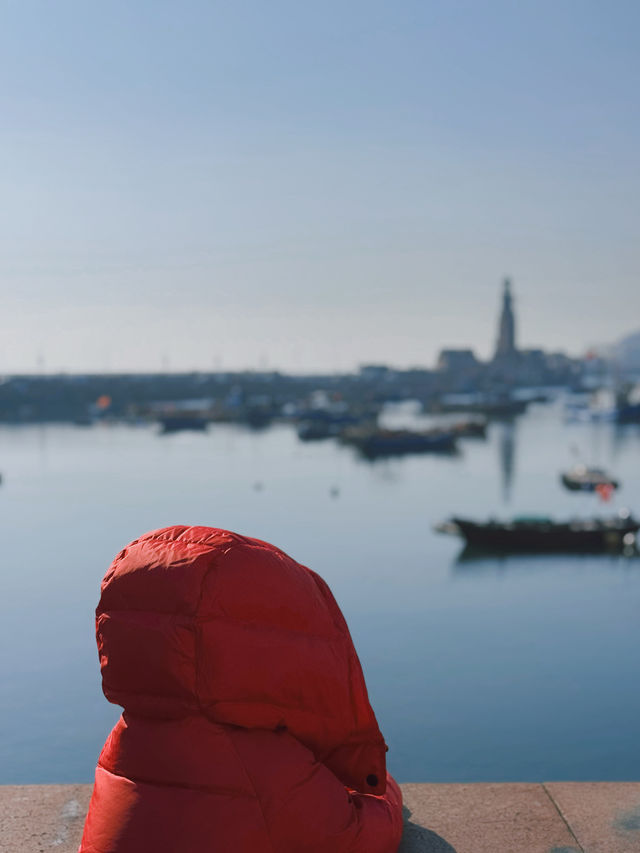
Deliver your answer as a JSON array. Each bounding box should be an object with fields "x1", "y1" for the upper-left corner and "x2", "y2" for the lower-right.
[{"x1": 0, "y1": 782, "x2": 640, "y2": 853}]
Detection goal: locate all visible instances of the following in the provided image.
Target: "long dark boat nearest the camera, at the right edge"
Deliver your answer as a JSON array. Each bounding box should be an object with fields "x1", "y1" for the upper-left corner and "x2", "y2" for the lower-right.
[{"x1": 436, "y1": 511, "x2": 640, "y2": 553}]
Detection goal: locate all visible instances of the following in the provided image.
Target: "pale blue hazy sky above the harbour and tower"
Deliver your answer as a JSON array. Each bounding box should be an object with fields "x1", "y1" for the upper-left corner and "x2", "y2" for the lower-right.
[{"x1": 0, "y1": 0, "x2": 640, "y2": 372}]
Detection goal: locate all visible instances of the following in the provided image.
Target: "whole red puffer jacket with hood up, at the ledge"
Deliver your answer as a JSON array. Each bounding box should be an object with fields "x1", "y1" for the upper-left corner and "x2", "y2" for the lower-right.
[{"x1": 79, "y1": 527, "x2": 402, "y2": 853}]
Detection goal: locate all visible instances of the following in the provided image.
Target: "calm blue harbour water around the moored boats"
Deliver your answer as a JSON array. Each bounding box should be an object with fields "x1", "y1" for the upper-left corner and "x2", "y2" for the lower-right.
[{"x1": 0, "y1": 407, "x2": 640, "y2": 783}]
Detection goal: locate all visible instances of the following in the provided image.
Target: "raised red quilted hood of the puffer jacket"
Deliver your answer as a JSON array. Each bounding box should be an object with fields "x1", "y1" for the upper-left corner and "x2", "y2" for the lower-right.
[{"x1": 96, "y1": 526, "x2": 386, "y2": 794}]
